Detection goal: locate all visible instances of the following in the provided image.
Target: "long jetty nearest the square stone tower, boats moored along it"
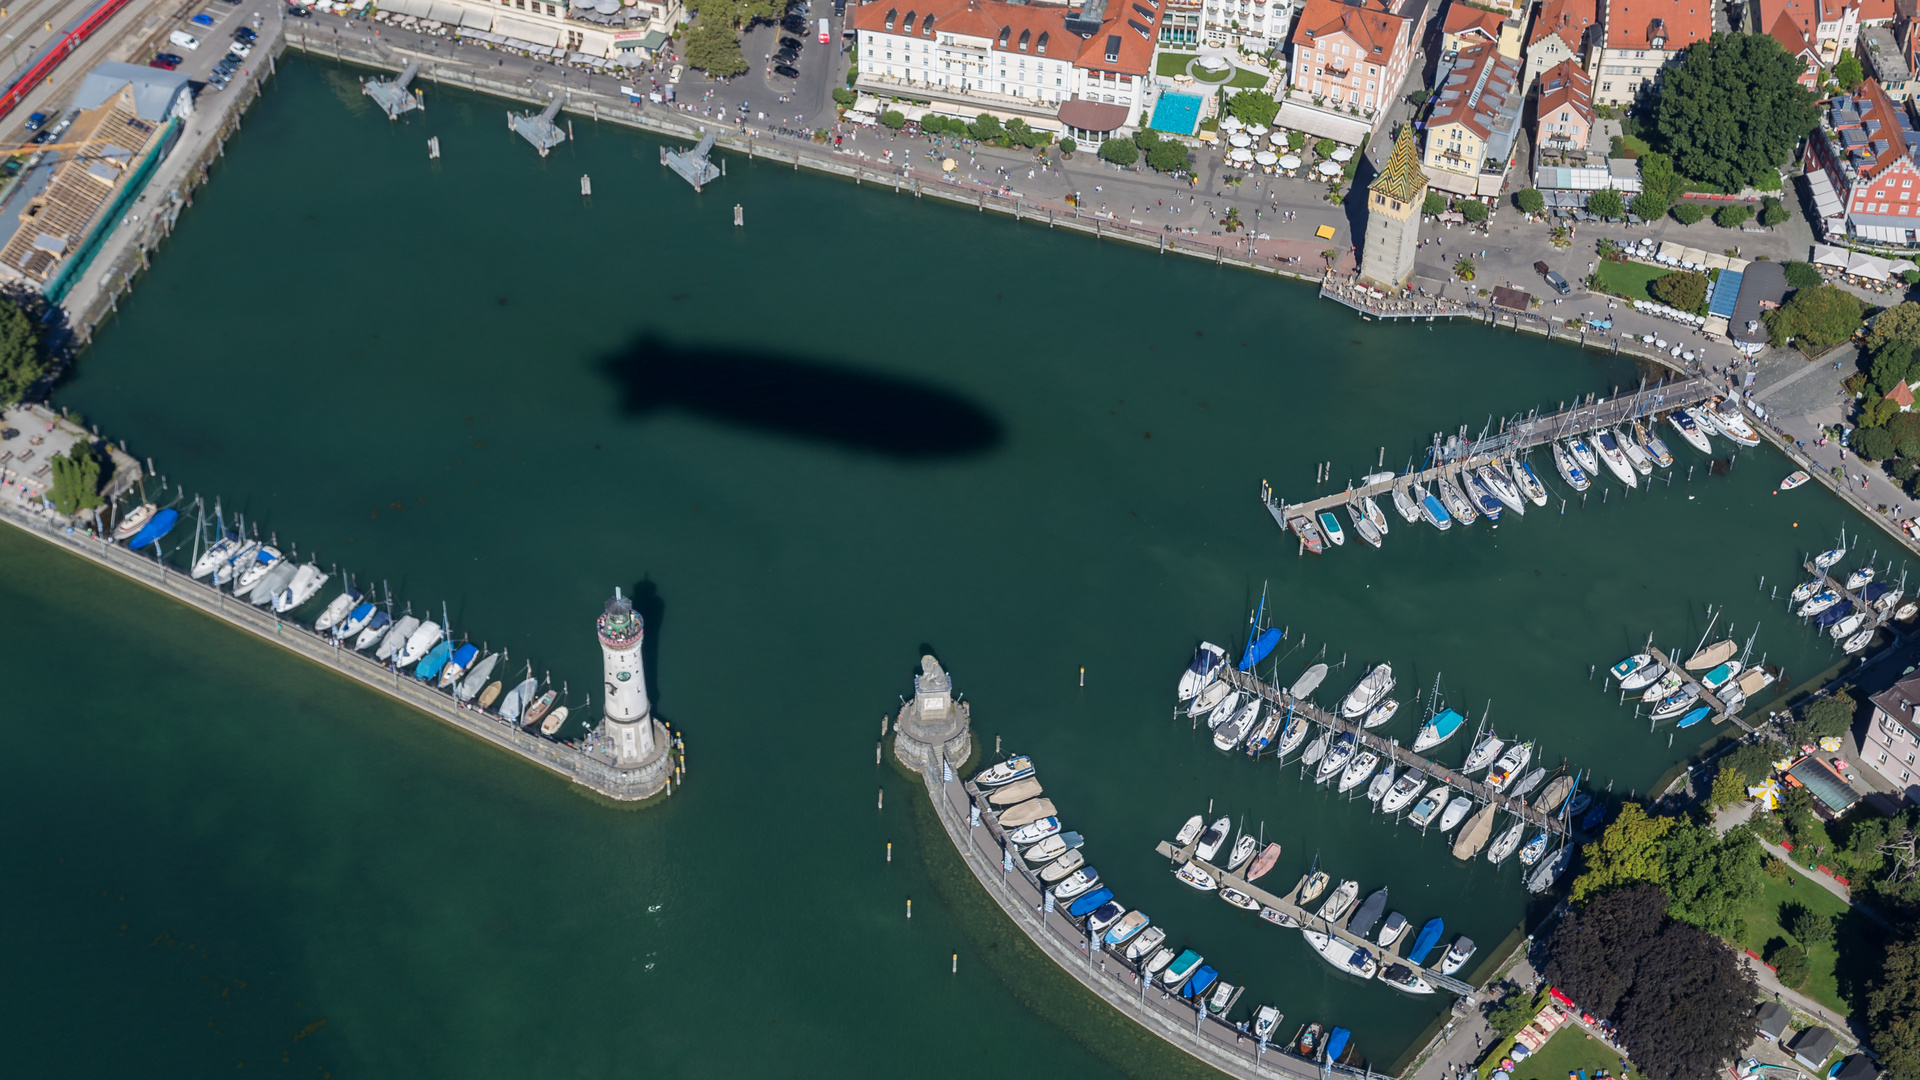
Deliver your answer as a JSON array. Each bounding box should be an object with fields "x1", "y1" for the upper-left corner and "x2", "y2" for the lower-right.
[{"x1": 1261, "y1": 375, "x2": 1722, "y2": 528}]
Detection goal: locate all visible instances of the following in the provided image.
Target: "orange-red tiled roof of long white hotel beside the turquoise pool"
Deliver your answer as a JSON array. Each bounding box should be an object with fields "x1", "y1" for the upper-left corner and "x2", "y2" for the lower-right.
[{"x1": 852, "y1": 0, "x2": 1160, "y2": 75}]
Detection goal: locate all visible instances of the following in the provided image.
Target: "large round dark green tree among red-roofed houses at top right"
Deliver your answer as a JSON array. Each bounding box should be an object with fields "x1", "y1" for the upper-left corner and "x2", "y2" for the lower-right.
[{"x1": 1653, "y1": 35, "x2": 1818, "y2": 192}]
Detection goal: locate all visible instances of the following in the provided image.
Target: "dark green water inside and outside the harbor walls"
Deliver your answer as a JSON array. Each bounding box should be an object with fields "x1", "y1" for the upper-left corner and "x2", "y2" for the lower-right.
[{"x1": 0, "y1": 56, "x2": 1899, "y2": 1076}]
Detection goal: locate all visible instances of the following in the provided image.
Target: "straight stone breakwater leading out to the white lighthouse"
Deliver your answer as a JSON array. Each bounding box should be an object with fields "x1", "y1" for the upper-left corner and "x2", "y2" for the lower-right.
[{"x1": 0, "y1": 488, "x2": 685, "y2": 803}]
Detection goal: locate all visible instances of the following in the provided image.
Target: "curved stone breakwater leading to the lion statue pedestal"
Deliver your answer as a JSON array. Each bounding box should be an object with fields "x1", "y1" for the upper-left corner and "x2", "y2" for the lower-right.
[{"x1": 922, "y1": 745, "x2": 1388, "y2": 1080}]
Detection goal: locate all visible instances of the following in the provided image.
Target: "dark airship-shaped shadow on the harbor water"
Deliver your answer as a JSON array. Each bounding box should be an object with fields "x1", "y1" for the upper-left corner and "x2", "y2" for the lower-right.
[{"x1": 601, "y1": 336, "x2": 1004, "y2": 461}]
